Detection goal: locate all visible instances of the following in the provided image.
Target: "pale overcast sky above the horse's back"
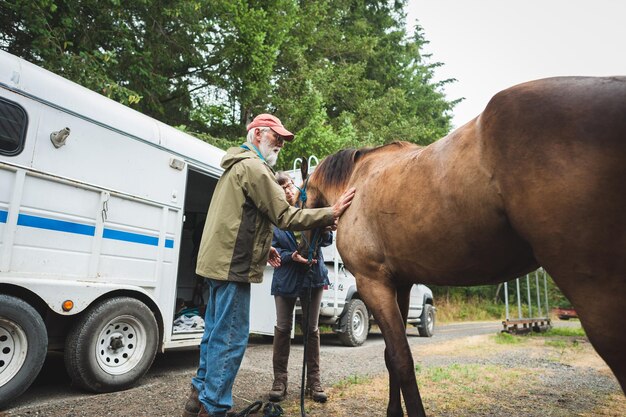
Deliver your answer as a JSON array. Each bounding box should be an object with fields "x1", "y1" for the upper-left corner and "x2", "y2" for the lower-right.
[{"x1": 407, "y1": 0, "x2": 626, "y2": 127}]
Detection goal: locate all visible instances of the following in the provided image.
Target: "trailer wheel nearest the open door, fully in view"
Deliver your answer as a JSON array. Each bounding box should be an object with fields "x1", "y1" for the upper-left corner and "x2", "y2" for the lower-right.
[{"x1": 65, "y1": 297, "x2": 159, "y2": 392}]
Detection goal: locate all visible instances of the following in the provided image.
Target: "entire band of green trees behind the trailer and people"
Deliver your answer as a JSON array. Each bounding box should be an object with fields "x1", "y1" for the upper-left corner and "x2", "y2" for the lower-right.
[{"x1": 0, "y1": 0, "x2": 457, "y2": 162}]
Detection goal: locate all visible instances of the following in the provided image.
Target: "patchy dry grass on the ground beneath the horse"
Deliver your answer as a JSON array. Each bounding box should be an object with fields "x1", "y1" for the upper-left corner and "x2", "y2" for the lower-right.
[{"x1": 284, "y1": 320, "x2": 626, "y2": 417}]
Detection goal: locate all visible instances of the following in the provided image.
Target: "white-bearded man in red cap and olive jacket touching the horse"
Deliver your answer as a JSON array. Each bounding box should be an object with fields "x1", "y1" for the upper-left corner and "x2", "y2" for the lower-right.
[{"x1": 183, "y1": 114, "x2": 354, "y2": 417}]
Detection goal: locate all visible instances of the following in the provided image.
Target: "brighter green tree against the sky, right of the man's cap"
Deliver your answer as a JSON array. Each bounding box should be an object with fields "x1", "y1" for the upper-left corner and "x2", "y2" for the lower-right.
[{"x1": 276, "y1": 1, "x2": 456, "y2": 169}]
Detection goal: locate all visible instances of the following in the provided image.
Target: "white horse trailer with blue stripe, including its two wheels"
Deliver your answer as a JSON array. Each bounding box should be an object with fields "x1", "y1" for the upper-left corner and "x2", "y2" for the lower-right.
[{"x1": 0, "y1": 51, "x2": 274, "y2": 407}]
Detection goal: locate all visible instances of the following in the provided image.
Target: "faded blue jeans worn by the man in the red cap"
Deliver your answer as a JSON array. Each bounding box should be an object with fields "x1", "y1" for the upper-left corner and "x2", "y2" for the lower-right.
[{"x1": 191, "y1": 279, "x2": 250, "y2": 414}]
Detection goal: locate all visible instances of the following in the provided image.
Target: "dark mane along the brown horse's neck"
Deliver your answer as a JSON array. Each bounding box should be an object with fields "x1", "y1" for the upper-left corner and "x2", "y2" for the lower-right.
[{"x1": 314, "y1": 142, "x2": 408, "y2": 188}]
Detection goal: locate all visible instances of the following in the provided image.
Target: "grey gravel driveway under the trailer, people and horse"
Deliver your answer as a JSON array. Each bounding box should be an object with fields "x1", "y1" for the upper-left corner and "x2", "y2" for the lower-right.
[{"x1": 0, "y1": 323, "x2": 626, "y2": 417}]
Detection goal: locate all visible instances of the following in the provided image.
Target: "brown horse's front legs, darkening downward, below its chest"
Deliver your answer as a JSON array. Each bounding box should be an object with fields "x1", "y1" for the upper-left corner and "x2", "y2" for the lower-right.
[{"x1": 357, "y1": 277, "x2": 426, "y2": 417}]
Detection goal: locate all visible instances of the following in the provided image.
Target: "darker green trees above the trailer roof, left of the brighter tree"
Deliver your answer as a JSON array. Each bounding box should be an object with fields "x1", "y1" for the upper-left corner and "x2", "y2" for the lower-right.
[{"x1": 0, "y1": 0, "x2": 291, "y2": 126}]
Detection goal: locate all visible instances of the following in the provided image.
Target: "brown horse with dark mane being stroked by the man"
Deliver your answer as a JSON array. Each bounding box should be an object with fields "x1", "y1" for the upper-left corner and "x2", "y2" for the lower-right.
[{"x1": 298, "y1": 77, "x2": 626, "y2": 417}]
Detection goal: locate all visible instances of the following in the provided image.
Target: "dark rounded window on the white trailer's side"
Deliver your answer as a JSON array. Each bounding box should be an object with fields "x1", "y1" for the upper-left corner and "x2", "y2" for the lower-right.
[{"x1": 0, "y1": 98, "x2": 28, "y2": 156}]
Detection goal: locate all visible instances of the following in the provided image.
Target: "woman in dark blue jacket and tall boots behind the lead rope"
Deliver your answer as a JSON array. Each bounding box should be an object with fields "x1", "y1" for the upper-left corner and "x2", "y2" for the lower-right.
[{"x1": 269, "y1": 172, "x2": 332, "y2": 402}]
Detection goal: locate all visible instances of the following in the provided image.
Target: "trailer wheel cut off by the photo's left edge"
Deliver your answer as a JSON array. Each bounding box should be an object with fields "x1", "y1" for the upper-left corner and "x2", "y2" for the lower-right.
[{"x1": 0, "y1": 294, "x2": 48, "y2": 409}]
